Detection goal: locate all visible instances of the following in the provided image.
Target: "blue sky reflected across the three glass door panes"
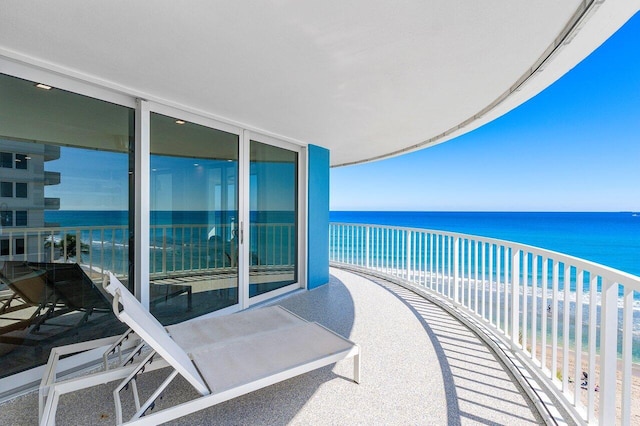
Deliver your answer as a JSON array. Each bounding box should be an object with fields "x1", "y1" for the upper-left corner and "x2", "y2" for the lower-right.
[{"x1": 45, "y1": 151, "x2": 295, "y2": 211}]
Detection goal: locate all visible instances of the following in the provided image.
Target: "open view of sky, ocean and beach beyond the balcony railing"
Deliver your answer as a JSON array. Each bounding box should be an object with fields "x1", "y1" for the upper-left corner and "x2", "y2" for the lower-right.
[{"x1": 331, "y1": 11, "x2": 640, "y2": 422}]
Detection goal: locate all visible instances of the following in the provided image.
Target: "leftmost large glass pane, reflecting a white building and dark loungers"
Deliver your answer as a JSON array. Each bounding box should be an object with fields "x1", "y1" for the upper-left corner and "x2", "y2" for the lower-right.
[{"x1": 0, "y1": 74, "x2": 135, "y2": 378}]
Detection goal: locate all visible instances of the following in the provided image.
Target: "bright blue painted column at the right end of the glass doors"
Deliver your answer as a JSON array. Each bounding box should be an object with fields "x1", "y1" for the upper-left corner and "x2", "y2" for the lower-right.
[{"x1": 307, "y1": 145, "x2": 329, "y2": 289}]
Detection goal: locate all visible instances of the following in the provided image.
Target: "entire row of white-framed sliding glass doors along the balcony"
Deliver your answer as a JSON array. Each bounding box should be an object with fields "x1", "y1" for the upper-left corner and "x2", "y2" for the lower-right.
[{"x1": 0, "y1": 71, "x2": 305, "y2": 391}]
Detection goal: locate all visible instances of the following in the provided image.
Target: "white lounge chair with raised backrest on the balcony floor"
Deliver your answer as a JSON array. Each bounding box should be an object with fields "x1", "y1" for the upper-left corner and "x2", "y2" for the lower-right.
[{"x1": 40, "y1": 274, "x2": 360, "y2": 425}]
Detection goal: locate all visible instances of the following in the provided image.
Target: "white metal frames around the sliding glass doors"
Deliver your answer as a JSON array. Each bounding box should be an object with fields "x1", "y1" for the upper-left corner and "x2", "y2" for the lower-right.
[{"x1": 0, "y1": 57, "x2": 307, "y2": 394}]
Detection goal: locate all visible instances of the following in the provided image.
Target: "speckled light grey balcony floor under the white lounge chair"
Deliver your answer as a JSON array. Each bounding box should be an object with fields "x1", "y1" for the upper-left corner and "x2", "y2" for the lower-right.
[{"x1": 0, "y1": 269, "x2": 542, "y2": 425}]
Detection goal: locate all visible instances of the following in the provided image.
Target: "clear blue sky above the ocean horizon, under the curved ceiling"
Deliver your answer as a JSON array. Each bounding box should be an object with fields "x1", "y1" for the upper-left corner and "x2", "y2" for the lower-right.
[{"x1": 331, "y1": 14, "x2": 640, "y2": 211}]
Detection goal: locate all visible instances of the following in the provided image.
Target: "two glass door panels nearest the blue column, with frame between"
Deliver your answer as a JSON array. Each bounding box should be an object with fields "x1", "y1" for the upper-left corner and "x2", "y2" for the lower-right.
[{"x1": 148, "y1": 117, "x2": 300, "y2": 324}]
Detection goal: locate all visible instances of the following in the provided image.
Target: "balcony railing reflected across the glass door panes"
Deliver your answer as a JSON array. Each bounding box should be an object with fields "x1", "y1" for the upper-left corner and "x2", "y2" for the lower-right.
[{"x1": 0, "y1": 223, "x2": 296, "y2": 276}]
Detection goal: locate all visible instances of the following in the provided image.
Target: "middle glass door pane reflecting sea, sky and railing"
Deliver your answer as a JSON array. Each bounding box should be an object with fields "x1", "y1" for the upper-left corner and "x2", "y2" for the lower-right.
[{"x1": 149, "y1": 113, "x2": 239, "y2": 325}]
